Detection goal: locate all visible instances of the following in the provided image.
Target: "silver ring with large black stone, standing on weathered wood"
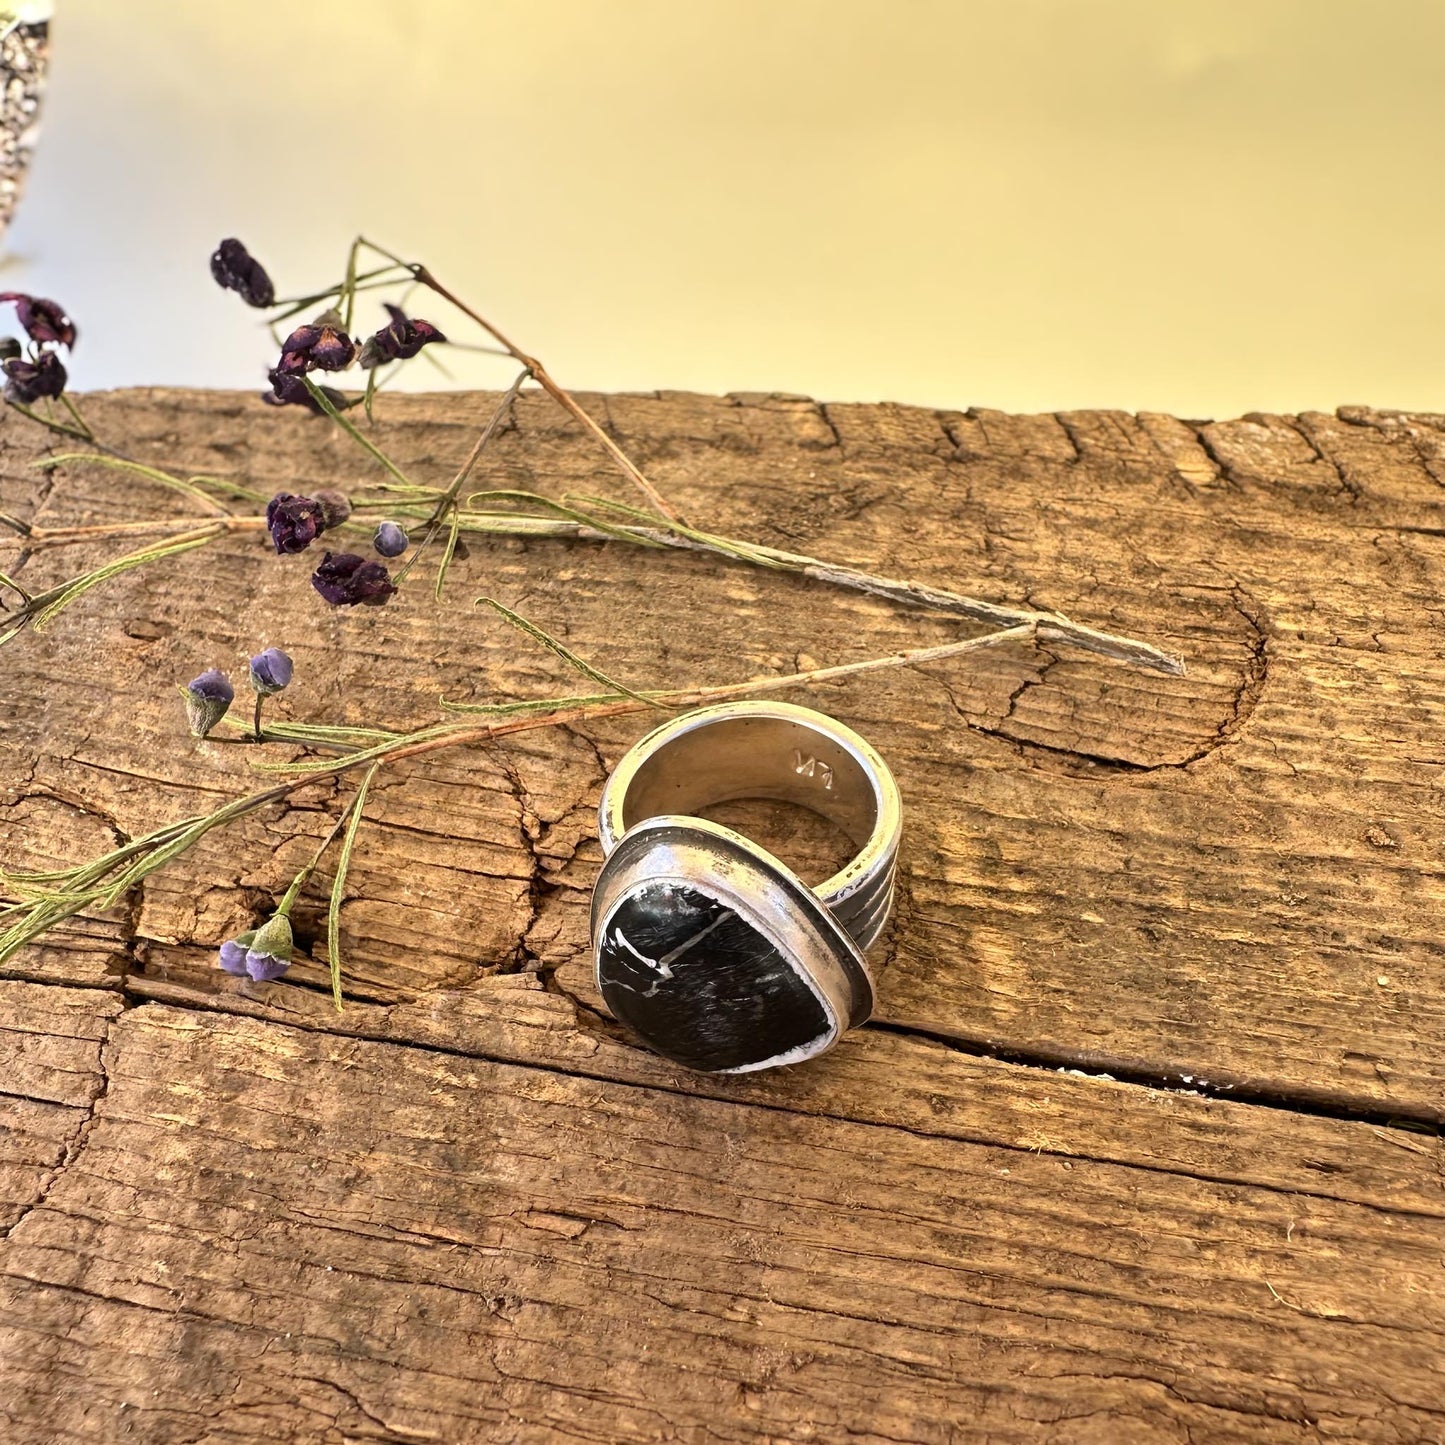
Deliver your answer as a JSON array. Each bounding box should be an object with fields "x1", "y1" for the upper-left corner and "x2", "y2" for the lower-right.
[{"x1": 592, "y1": 702, "x2": 903, "y2": 1074}]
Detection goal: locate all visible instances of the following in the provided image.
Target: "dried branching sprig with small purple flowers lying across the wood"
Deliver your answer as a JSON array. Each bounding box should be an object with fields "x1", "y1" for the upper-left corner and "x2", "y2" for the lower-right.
[{"x1": 0, "y1": 228, "x2": 1183, "y2": 1007}]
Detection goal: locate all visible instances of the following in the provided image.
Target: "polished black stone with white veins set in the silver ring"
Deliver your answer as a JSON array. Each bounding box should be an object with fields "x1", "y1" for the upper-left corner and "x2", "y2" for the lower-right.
[{"x1": 597, "y1": 883, "x2": 829, "y2": 1071}]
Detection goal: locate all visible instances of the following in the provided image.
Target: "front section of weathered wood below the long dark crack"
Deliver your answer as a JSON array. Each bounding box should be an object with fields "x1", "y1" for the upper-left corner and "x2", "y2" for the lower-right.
[{"x1": 0, "y1": 980, "x2": 1445, "y2": 1445}]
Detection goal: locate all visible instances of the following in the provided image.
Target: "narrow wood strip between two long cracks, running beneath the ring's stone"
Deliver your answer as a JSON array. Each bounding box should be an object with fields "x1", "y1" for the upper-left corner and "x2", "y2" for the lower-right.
[{"x1": 133, "y1": 951, "x2": 1445, "y2": 1218}]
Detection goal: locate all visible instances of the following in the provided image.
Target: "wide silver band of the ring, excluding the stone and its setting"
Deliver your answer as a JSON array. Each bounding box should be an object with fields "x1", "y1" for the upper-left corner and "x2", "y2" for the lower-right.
[{"x1": 597, "y1": 702, "x2": 903, "y2": 952}]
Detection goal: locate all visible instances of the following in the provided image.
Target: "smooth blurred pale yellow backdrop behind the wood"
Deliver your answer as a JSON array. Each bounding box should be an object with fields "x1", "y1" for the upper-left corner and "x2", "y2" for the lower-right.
[{"x1": 11, "y1": 0, "x2": 1445, "y2": 416}]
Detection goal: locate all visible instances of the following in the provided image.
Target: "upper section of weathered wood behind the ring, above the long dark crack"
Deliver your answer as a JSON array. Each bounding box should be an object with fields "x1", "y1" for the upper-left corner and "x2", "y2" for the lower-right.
[{"x1": 0, "y1": 392, "x2": 1445, "y2": 1118}]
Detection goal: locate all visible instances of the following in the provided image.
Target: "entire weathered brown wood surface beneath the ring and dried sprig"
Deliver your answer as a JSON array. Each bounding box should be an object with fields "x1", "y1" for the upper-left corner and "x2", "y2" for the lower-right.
[{"x1": 0, "y1": 392, "x2": 1445, "y2": 1445}]
